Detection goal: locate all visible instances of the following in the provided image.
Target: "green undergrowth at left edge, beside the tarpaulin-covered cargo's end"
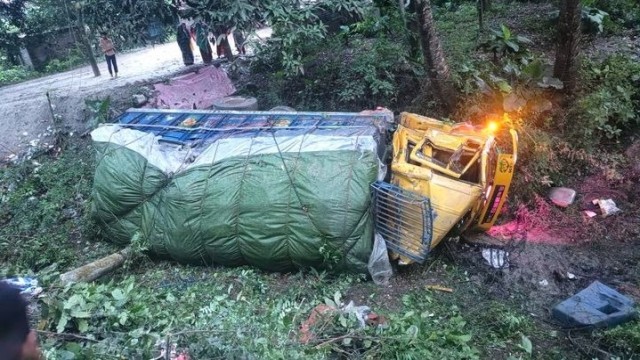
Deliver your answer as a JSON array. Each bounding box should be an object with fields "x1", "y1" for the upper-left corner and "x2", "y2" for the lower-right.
[{"x1": 0, "y1": 139, "x2": 114, "y2": 273}]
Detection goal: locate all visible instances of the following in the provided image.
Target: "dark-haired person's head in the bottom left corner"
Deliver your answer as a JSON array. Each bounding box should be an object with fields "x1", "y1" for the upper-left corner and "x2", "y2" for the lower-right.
[{"x1": 0, "y1": 281, "x2": 42, "y2": 360}]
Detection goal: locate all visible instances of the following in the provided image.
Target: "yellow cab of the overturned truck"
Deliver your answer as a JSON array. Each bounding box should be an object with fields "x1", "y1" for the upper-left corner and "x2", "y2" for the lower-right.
[{"x1": 382, "y1": 113, "x2": 517, "y2": 264}]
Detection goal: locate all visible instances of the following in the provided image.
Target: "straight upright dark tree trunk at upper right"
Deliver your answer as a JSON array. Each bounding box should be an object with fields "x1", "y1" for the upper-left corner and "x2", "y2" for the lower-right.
[{"x1": 553, "y1": 0, "x2": 581, "y2": 95}]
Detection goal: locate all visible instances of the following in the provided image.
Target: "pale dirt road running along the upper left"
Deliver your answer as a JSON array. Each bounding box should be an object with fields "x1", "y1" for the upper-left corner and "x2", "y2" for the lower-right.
[{"x1": 0, "y1": 28, "x2": 271, "y2": 160}]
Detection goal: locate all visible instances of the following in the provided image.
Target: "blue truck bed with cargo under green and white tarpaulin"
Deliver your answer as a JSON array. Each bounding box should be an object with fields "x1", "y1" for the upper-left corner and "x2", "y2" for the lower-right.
[{"x1": 91, "y1": 110, "x2": 393, "y2": 271}]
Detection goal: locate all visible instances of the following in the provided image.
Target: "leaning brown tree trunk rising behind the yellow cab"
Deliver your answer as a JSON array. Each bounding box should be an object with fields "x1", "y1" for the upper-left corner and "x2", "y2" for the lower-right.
[{"x1": 418, "y1": 0, "x2": 457, "y2": 111}]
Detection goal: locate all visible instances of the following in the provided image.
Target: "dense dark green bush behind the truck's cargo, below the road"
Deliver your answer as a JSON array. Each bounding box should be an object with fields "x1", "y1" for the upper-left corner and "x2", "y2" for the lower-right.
[{"x1": 246, "y1": 2, "x2": 420, "y2": 111}]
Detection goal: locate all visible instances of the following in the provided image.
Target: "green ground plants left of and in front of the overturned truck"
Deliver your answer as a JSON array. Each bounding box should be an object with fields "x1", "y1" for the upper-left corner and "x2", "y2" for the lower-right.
[{"x1": 0, "y1": 138, "x2": 556, "y2": 359}]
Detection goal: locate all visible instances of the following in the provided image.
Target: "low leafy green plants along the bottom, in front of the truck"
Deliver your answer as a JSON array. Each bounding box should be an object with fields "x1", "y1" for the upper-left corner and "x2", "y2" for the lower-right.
[{"x1": 35, "y1": 267, "x2": 504, "y2": 359}]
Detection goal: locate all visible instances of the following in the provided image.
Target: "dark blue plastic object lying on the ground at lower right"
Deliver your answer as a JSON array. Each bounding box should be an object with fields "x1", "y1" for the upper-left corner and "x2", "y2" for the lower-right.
[{"x1": 553, "y1": 281, "x2": 636, "y2": 327}]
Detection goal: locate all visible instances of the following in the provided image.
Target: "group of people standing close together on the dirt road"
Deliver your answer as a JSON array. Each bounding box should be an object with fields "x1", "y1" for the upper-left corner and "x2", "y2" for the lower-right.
[{"x1": 177, "y1": 21, "x2": 245, "y2": 66}]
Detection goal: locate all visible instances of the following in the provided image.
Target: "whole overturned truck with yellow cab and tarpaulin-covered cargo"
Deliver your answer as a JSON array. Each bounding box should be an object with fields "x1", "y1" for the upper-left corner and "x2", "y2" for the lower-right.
[{"x1": 91, "y1": 109, "x2": 516, "y2": 272}]
